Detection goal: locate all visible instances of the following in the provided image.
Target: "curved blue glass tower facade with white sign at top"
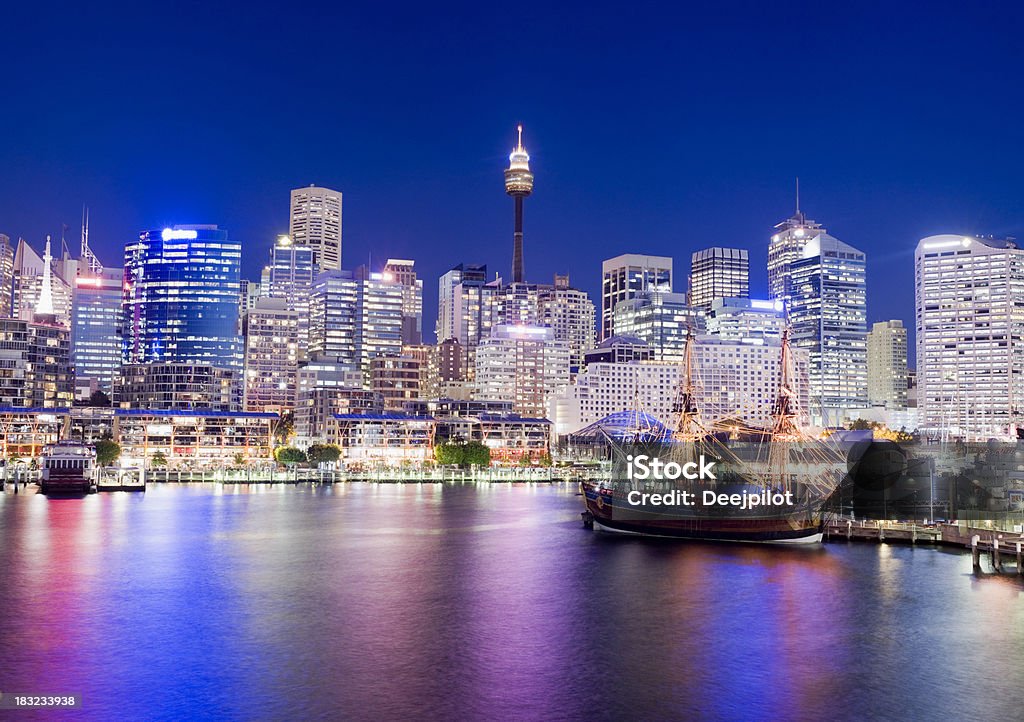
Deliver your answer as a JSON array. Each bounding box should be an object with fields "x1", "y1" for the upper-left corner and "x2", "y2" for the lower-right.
[{"x1": 122, "y1": 225, "x2": 243, "y2": 372}]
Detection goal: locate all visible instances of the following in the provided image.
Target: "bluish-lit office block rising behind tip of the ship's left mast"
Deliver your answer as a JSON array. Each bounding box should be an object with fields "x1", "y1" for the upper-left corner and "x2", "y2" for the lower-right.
[{"x1": 614, "y1": 291, "x2": 703, "y2": 360}]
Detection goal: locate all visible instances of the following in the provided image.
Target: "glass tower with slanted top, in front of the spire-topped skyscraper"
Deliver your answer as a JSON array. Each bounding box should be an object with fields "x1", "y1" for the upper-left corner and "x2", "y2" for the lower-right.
[{"x1": 788, "y1": 231, "x2": 867, "y2": 425}]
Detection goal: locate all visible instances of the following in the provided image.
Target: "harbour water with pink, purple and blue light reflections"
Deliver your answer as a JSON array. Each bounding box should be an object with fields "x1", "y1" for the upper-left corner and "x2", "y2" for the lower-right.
[{"x1": 0, "y1": 483, "x2": 1024, "y2": 720}]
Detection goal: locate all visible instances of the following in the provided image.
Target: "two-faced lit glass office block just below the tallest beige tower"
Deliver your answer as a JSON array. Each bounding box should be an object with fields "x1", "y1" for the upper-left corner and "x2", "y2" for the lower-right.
[{"x1": 309, "y1": 267, "x2": 403, "y2": 388}]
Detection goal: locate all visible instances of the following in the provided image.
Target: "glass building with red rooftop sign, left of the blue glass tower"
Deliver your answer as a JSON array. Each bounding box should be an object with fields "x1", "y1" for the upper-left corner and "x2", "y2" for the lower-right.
[{"x1": 71, "y1": 268, "x2": 124, "y2": 393}]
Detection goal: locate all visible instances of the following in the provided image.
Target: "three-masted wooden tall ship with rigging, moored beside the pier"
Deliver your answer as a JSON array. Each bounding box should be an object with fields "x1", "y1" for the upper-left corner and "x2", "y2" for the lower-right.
[{"x1": 582, "y1": 331, "x2": 847, "y2": 544}]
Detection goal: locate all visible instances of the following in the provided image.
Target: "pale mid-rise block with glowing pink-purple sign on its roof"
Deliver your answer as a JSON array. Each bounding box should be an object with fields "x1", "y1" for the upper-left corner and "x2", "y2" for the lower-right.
[{"x1": 475, "y1": 325, "x2": 569, "y2": 417}]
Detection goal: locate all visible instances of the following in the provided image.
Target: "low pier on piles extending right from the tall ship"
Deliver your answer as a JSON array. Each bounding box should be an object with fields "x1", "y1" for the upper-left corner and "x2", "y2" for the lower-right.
[{"x1": 824, "y1": 519, "x2": 1024, "y2": 577}]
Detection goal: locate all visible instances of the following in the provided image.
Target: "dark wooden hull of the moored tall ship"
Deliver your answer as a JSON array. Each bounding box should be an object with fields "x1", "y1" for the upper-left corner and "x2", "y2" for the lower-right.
[{"x1": 582, "y1": 481, "x2": 824, "y2": 544}]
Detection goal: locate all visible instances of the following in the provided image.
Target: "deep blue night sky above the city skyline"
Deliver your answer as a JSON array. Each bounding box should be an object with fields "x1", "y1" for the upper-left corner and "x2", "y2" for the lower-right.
[{"x1": 0, "y1": 2, "x2": 1024, "y2": 348}]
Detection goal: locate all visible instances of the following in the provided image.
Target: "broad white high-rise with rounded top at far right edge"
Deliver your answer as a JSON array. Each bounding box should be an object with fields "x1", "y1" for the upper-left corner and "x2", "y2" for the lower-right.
[{"x1": 914, "y1": 235, "x2": 1024, "y2": 441}]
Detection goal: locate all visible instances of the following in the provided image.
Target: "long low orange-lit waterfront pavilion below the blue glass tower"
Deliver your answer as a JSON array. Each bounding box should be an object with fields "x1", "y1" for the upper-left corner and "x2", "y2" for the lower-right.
[{"x1": 114, "y1": 409, "x2": 279, "y2": 471}]
